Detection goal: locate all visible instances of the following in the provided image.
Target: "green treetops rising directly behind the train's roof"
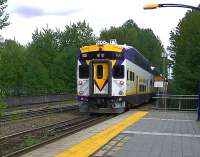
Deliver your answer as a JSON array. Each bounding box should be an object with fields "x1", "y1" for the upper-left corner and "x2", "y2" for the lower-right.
[{"x1": 100, "y1": 20, "x2": 163, "y2": 68}]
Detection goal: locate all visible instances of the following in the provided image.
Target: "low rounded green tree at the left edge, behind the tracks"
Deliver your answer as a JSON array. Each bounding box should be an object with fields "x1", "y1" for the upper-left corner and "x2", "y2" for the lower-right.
[{"x1": 0, "y1": 40, "x2": 26, "y2": 95}]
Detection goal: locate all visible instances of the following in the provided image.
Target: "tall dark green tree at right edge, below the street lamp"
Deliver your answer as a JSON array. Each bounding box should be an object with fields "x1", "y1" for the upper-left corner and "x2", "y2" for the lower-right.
[{"x1": 169, "y1": 11, "x2": 200, "y2": 94}]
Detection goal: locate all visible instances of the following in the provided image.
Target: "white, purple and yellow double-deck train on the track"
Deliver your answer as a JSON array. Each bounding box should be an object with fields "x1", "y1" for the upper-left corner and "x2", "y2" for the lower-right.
[{"x1": 77, "y1": 40, "x2": 158, "y2": 113}]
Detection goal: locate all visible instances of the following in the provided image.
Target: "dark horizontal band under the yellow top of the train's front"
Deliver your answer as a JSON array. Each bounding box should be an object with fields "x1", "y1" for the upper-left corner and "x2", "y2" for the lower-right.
[{"x1": 80, "y1": 51, "x2": 123, "y2": 60}]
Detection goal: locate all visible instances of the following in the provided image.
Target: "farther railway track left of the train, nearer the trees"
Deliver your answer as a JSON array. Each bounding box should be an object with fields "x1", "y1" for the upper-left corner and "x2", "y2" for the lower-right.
[{"x1": 0, "y1": 105, "x2": 79, "y2": 122}]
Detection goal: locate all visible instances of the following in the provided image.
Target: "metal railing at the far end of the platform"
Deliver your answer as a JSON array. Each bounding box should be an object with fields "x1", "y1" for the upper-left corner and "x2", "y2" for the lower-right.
[{"x1": 153, "y1": 95, "x2": 198, "y2": 111}]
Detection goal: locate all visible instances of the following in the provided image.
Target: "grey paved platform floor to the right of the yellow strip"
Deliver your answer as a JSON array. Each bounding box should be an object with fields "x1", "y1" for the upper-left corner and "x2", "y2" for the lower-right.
[{"x1": 91, "y1": 111, "x2": 200, "y2": 157}]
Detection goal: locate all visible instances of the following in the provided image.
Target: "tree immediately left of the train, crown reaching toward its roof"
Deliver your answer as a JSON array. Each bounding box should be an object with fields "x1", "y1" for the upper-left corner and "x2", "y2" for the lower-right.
[{"x1": 59, "y1": 21, "x2": 96, "y2": 92}]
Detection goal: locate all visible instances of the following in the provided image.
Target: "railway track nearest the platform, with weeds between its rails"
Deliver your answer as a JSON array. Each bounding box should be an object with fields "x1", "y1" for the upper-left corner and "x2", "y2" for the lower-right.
[{"x1": 0, "y1": 116, "x2": 113, "y2": 157}]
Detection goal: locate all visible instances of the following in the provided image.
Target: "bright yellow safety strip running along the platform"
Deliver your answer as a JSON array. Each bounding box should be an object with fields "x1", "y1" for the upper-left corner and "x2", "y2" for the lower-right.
[{"x1": 55, "y1": 112, "x2": 147, "y2": 157}]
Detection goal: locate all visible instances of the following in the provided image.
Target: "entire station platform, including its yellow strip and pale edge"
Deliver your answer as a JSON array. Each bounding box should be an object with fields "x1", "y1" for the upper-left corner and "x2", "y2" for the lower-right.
[{"x1": 20, "y1": 110, "x2": 200, "y2": 157}]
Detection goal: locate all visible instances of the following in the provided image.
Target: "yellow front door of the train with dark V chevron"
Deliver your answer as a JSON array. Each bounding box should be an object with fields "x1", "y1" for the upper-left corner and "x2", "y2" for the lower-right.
[{"x1": 90, "y1": 61, "x2": 111, "y2": 95}]
